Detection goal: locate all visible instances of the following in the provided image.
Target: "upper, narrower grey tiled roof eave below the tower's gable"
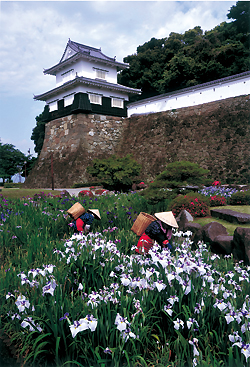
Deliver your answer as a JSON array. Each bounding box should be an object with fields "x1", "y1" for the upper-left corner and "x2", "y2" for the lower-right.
[{"x1": 43, "y1": 52, "x2": 129, "y2": 75}]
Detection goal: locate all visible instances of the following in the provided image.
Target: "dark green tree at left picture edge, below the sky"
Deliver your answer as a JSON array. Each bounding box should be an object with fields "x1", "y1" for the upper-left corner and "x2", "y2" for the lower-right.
[{"x1": 0, "y1": 142, "x2": 27, "y2": 182}]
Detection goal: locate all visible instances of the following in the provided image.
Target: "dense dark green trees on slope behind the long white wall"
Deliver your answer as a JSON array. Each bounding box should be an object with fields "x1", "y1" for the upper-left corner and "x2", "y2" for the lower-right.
[{"x1": 118, "y1": 1, "x2": 250, "y2": 99}]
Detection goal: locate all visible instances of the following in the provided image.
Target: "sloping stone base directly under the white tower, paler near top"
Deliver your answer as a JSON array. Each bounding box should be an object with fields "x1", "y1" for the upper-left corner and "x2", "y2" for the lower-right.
[{"x1": 25, "y1": 113, "x2": 124, "y2": 188}]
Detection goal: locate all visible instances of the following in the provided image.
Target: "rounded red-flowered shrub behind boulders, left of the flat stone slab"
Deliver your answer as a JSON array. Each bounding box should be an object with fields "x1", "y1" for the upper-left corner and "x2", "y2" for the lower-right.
[{"x1": 170, "y1": 193, "x2": 209, "y2": 217}]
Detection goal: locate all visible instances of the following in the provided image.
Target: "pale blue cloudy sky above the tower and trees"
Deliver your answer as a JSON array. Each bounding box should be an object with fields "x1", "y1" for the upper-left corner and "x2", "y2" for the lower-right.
[{"x1": 0, "y1": 1, "x2": 236, "y2": 156}]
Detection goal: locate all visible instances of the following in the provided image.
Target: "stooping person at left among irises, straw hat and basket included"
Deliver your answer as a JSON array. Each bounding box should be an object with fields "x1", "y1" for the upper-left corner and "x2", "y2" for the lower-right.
[{"x1": 67, "y1": 203, "x2": 101, "y2": 233}]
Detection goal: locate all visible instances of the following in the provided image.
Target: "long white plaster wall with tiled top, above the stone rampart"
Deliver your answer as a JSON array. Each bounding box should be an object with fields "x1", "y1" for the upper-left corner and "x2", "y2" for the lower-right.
[{"x1": 128, "y1": 72, "x2": 250, "y2": 117}]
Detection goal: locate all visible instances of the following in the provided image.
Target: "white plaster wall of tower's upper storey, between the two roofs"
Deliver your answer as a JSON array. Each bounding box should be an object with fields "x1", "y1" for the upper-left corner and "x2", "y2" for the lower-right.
[{"x1": 56, "y1": 60, "x2": 117, "y2": 87}]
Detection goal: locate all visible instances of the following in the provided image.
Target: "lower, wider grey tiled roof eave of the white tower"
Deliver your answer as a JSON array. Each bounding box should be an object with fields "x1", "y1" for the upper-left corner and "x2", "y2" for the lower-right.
[{"x1": 34, "y1": 77, "x2": 141, "y2": 101}]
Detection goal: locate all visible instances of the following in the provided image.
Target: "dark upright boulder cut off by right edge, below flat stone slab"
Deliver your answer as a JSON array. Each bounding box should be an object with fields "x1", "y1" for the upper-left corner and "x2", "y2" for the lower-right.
[{"x1": 233, "y1": 227, "x2": 250, "y2": 265}]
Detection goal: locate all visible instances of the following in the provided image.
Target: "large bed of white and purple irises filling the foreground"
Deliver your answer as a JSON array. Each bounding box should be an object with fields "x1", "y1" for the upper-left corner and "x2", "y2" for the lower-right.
[{"x1": 0, "y1": 194, "x2": 250, "y2": 367}]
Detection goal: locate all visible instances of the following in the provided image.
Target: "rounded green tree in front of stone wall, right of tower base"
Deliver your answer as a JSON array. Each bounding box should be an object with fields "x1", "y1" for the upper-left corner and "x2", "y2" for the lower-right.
[{"x1": 87, "y1": 154, "x2": 141, "y2": 191}]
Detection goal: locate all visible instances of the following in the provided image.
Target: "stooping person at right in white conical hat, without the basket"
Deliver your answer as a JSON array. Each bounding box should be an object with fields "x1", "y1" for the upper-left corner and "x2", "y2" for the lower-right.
[{"x1": 135, "y1": 212, "x2": 178, "y2": 254}]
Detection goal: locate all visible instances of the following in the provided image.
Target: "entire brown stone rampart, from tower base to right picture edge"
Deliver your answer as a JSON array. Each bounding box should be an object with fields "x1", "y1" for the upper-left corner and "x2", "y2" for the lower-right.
[{"x1": 26, "y1": 96, "x2": 250, "y2": 188}]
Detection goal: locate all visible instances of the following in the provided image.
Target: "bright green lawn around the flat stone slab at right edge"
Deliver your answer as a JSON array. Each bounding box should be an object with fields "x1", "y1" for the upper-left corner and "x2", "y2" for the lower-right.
[{"x1": 194, "y1": 205, "x2": 250, "y2": 236}]
